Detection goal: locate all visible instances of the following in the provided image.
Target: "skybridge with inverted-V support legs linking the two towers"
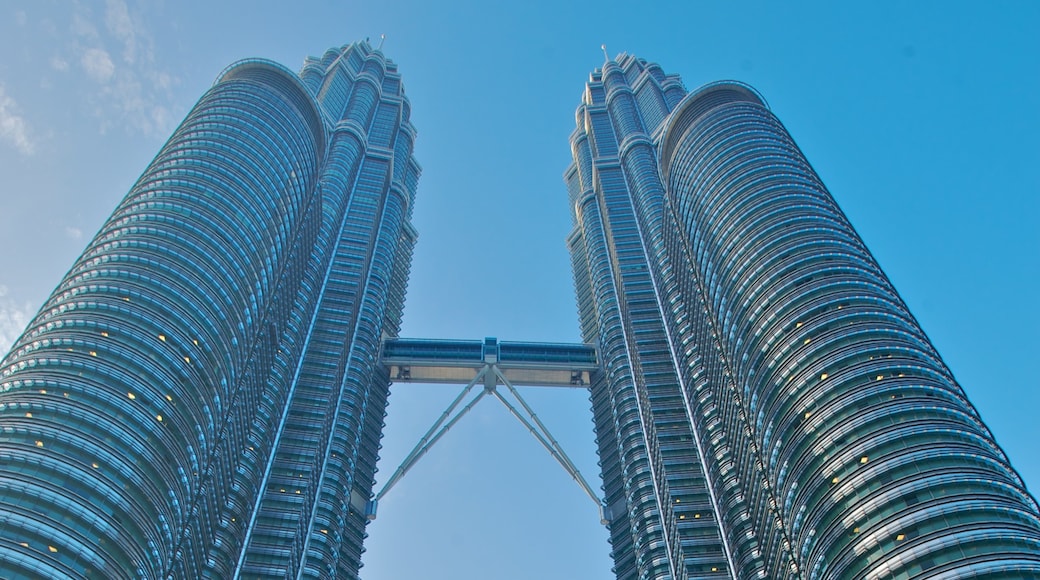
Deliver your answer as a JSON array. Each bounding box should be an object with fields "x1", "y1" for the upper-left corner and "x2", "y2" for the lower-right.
[{"x1": 372, "y1": 337, "x2": 607, "y2": 525}]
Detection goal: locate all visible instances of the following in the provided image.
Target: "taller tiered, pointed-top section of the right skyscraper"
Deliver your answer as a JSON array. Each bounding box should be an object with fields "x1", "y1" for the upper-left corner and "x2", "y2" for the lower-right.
[{"x1": 567, "y1": 57, "x2": 729, "y2": 579}]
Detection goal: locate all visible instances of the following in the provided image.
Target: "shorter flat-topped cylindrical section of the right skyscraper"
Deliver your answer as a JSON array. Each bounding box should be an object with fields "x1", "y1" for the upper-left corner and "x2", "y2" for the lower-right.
[{"x1": 661, "y1": 83, "x2": 1040, "y2": 579}]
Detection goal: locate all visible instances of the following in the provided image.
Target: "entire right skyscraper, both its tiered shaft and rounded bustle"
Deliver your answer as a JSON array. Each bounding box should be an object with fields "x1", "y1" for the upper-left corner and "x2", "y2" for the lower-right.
[{"x1": 565, "y1": 55, "x2": 1040, "y2": 580}]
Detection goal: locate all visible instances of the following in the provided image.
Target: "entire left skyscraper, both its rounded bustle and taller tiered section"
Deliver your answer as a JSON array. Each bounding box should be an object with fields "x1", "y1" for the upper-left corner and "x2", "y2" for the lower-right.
[{"x1": 0, "y1": 43, "x2": 419, "y2": 578}]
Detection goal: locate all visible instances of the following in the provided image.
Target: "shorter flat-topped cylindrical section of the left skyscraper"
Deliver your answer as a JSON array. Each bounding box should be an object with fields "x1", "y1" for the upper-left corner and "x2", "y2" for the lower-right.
[{"x1": 0, "y1": 57, "x2": 324, "y2": 578}]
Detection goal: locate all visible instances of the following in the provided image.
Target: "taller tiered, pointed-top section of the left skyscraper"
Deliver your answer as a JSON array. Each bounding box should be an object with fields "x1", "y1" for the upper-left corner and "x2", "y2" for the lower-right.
[{"x1": 235, "y1": 43, "x2": 419, "y2": 578}]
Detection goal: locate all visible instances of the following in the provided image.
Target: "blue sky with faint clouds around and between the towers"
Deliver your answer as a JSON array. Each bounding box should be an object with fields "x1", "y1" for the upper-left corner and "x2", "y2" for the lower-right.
[{"x1": 0, "y1": 0, "x2": 1040, "y2": 580}]
